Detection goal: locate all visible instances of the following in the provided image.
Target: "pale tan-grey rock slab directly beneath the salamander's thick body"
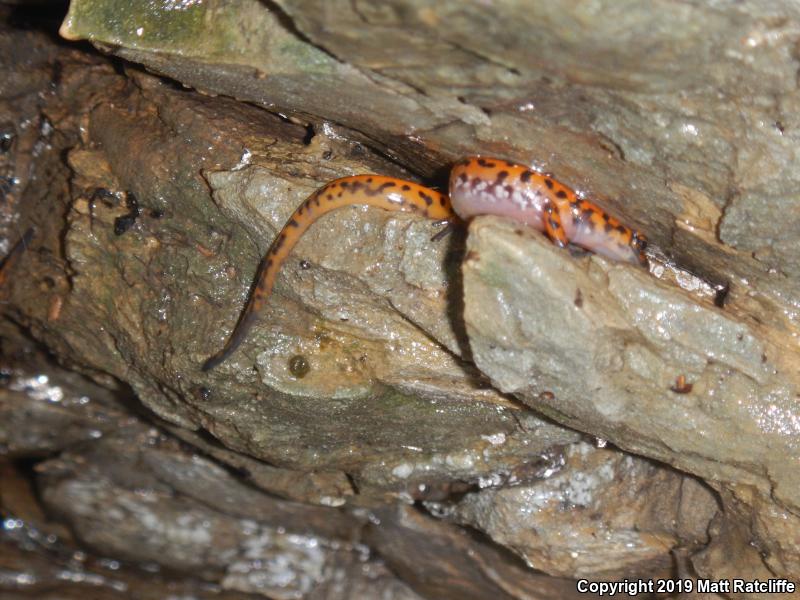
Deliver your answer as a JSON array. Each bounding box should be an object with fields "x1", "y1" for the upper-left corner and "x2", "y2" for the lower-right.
[{"x1": 464, "y1": 218, "x2": 800, "y2": 578}]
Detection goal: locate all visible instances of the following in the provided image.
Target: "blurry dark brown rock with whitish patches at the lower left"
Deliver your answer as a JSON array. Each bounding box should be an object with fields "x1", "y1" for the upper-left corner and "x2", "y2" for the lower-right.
[{"x1": 38, "y1": 425, "x2": 408, "y2": 598}]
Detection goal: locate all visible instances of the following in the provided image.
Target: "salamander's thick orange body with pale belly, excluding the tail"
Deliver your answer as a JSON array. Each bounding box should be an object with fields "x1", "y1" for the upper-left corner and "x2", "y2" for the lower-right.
[{"x1": 450, "y1": 156, "x2": 647, "y2": 265}]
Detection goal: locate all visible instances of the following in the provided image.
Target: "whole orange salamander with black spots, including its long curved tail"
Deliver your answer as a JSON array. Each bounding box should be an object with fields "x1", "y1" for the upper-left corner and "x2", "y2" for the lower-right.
[{"x1": 203, "y1": 156, "x2": 646, "y2": 371}]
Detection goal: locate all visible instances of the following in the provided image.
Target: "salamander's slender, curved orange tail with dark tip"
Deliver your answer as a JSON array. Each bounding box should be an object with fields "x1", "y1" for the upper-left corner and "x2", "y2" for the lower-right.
[{"x1": 203, "y1": 175, "x2": 456, "y2": 371}]
